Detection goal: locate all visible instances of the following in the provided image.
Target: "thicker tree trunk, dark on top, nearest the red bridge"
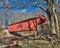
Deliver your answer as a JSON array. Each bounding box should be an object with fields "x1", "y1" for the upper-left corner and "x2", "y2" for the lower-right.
[{"x1": 46, "y1": 0, "x2": 56, "y2": 34}]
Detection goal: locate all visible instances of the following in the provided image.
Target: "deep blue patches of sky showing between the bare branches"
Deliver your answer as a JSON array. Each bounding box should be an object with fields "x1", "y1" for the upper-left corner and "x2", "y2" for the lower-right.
[{"x1": 0, "y1": 0, "x2": 46, "y2": 12}]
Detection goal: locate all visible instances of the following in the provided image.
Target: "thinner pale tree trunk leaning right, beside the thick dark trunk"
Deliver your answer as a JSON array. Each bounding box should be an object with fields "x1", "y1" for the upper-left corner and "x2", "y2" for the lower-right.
[{"x1": 53, "y1": 4, "x2": 60, "y2": 38}]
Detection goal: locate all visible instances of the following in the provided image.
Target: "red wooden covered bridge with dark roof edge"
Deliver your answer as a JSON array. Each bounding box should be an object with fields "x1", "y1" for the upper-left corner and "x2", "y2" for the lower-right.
[{"x1": 8, "y1": 15, "x2": 46, "y2": 32}]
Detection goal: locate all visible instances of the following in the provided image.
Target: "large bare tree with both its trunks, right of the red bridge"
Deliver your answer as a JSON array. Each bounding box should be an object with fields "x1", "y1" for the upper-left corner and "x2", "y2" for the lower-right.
[{"x1": 46, "y1": 0, "x2": 60, "y2": 37}]
